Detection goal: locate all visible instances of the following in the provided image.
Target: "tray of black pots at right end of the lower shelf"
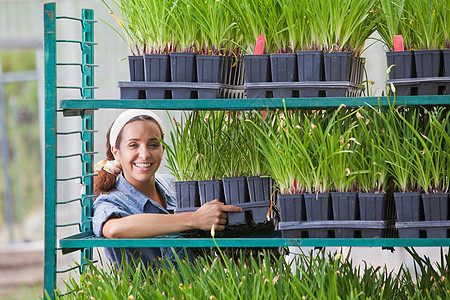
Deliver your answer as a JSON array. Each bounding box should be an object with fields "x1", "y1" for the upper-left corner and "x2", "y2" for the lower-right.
[{"x1": 394, "y1": 192, "x2": 450, "y2": 238}]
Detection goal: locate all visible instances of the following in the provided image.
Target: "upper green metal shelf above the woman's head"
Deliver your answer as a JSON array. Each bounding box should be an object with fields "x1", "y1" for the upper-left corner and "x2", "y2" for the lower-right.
[{"x1": 60, "y1": 95, "x2": 450, "y2": 110}]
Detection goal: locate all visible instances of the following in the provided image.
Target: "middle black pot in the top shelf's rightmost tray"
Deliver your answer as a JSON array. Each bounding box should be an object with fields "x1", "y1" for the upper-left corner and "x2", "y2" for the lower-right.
[{"x1": 414, "y1": 49, "x2": 442, "y2": 78}]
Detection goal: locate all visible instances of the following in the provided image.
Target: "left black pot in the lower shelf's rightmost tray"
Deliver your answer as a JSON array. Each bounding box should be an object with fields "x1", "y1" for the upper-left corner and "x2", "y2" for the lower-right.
[{"x1": 394, "y1": 192, "x2": 424, "y2": 222}]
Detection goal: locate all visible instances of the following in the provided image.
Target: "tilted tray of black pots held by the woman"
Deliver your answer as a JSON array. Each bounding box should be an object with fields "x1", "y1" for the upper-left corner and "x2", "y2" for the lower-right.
[{"x1": 175, "y1": 176, "x2": 278, "y2": 237}]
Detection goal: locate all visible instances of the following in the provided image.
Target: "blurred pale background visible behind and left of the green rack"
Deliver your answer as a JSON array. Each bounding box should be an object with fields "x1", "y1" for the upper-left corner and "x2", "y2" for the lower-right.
[{"x1": 0, "y1": 0, "x2": 440, "y2": 299}]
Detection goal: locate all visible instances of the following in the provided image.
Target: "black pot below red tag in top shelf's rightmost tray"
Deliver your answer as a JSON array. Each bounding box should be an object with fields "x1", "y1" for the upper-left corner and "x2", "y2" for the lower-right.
[{"x1": 386, "y1": 50, "x2": 416, "y2": 79}]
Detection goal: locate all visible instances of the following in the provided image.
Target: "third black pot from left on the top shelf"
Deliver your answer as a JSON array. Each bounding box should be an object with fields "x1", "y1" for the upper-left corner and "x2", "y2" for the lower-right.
[{"x1": 170, "y1": 52, "x2": 197, "y2": 82}]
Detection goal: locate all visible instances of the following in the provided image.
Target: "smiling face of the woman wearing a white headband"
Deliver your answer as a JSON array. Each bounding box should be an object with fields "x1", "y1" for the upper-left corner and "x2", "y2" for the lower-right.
[{"x1": 112, "y1": 120, "x2": 164, "y2": 187}]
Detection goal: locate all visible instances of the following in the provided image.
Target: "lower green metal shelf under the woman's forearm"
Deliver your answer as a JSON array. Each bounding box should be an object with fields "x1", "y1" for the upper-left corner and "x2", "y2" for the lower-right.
[{"x1": 59, "y1": 231, "x2": 450, "y2": 253}]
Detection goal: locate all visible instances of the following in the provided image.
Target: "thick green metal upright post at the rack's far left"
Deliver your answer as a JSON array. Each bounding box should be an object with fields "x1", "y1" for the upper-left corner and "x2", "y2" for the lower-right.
[{"x1": 44, "y1": 3, "x2": 57, "y2": 299}]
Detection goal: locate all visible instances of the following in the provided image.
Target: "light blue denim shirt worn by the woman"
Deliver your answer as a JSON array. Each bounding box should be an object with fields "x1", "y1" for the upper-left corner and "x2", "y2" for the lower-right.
[{"x1": 92, "y1": 174, "x2": 190, "y2": 267}]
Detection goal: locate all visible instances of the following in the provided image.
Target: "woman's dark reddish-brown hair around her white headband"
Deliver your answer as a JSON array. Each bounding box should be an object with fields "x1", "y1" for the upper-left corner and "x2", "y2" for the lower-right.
[{"x1": 94, "y1": 115, "x2": 164, "y2": 195}]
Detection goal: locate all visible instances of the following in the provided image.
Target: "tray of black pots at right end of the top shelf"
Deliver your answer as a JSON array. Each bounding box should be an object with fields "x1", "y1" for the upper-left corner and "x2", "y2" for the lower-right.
[{"x1": 386, "y1": 49, "x2": 450, "y2": 96}]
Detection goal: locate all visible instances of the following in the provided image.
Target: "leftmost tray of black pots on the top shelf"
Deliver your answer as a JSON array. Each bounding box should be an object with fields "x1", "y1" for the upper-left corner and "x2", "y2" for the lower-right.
[{"x1": 118, "y1": 53, "x2": 244, "y2": 99}]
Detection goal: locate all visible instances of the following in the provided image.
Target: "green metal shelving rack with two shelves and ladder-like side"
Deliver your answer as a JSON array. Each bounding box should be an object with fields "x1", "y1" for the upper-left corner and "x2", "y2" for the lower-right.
[{"x1": 44, "y1": 3, "x2": 450, "y2": 297}]
